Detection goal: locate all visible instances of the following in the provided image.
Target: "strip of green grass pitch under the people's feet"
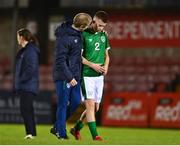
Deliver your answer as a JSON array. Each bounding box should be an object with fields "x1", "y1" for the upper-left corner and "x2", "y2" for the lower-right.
[{"x1": 0, "y1": 124, "x2": 180, "y2": 145}]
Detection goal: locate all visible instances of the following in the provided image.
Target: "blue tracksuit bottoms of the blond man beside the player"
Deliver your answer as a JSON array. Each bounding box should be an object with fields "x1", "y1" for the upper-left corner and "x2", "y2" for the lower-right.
[{"x1": 54, "y1": 80, "x2": 81, "y2": 138}]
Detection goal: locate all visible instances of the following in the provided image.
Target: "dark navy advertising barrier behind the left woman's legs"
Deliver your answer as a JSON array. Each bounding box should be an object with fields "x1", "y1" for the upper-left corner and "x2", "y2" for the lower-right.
[{"x1": 0, "y1": 90, "x2": 52, "y2": 124}]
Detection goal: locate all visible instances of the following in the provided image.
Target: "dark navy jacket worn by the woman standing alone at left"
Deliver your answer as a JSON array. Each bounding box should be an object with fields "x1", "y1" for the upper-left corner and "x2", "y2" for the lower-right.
[{"x1": 14, "y1": 43, "x2": 40, "y2": 94}]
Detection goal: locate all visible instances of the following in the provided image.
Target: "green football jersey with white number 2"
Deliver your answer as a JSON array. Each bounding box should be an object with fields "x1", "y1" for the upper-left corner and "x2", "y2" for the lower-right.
[{"x1": 82, "y1": 30, "x2": 110, "y2": 77}]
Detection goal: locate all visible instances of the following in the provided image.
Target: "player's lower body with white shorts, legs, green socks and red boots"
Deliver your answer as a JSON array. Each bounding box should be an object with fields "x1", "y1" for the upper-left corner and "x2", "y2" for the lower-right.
[{"x1": 70, "y1": 77, "x2": 104, "y2": 140}]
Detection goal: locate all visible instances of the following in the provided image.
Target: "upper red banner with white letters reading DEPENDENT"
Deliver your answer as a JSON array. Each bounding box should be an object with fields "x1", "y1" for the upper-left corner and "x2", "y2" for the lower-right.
[{"x1": 107, "y1": 12, "x2": 180, "y2": 48}]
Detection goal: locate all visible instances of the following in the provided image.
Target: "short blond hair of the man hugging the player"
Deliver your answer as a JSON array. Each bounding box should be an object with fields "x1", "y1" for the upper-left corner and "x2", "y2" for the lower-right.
[{"x1": 73, "y1": 13, "x2": 92, "y2": 28}]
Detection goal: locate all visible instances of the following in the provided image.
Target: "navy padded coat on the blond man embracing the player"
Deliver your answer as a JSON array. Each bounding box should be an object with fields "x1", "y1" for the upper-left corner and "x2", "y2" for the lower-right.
[{"x1": 53, "y1": 22, "x2": 82, "y2": 82}]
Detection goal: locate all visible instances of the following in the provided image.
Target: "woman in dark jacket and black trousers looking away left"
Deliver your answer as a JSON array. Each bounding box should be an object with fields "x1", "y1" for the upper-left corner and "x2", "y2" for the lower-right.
[{"x1": 14, "y1": 28, "x2": 40, "y2": 139}]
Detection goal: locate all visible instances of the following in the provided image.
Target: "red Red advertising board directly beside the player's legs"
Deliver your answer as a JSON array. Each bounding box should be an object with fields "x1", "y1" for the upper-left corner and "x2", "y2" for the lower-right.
[{"x1": 102, "y1": 93, "x2": 148, "y2": 127}]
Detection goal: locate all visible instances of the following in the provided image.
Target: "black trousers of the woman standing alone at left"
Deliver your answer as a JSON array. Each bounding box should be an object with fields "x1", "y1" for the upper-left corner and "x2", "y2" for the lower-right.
[{"x1": 19, "y1": 92, "x2": 36, "y2": 136}]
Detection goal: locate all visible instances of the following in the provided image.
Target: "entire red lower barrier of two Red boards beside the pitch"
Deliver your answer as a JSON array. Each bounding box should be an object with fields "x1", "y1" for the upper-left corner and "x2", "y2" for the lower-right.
[{"x1": 101, "y1": 93, "x2": 180, "y2": 128}]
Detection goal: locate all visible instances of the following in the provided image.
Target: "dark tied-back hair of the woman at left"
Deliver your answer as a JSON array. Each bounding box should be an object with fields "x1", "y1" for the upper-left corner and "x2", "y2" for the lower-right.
[{"x1": 17, "y1": 28, "x2": 39, "y2": 46}]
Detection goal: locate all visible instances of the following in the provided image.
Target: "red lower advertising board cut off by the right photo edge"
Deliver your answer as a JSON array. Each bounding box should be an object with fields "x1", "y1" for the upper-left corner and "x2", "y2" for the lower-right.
[{"x1": 150, "y1": 93, "x2": 180, "y2": 128}]
